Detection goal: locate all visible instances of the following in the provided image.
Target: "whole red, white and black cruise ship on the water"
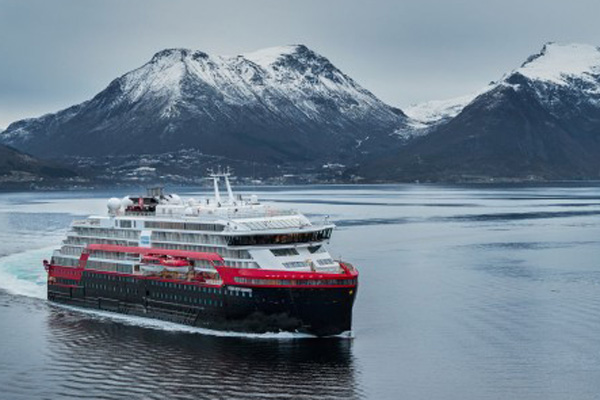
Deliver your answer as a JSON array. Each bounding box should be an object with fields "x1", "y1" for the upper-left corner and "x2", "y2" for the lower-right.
[{"x1": 44, "y1": 172, "x2": 358, "y2": 336}]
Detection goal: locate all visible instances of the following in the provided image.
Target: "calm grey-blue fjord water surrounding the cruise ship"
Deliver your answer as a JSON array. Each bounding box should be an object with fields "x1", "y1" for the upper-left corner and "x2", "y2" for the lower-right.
[{"x1": 0, "y1": 184, "x2": 600, "y2": 399}]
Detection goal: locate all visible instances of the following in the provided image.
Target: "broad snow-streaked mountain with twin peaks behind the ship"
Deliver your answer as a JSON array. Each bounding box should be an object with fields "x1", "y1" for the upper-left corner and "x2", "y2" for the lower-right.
[{"x1": 0, "y1": 45, "x2": 408, "y2": 173}]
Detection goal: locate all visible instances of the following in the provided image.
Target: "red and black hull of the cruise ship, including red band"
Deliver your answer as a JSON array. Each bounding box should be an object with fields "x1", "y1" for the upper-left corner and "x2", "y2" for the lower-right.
[{"x1": 46, "y1": 245, "x2": 358, "y2": 336}]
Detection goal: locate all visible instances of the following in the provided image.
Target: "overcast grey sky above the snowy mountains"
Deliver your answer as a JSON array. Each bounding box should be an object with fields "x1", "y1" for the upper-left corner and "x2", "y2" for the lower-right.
[{"x1": 0, "y1": 0, "x2": 600, "y2": 129}]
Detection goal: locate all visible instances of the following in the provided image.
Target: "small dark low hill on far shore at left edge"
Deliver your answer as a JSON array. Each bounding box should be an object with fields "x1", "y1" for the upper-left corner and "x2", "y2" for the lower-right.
[{"x1": 0, "y1": 145, "x2": 76, "y2": 189}]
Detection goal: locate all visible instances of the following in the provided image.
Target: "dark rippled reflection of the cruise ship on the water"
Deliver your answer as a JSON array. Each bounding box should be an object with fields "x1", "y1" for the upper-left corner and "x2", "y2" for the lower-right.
[{"x1": 46, "y1": 308, "x2": 360, "y2": 399}]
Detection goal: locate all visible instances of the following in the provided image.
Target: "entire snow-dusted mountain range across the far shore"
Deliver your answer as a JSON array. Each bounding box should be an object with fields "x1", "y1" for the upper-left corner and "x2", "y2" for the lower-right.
[{"x1": 0, "y1": 44, "x2": 600, "y2": 181}]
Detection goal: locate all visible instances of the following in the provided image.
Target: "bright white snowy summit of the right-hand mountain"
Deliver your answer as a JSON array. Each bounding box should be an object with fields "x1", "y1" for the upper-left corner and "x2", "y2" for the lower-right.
[{"x1": 515, "y1": 42, "x2": 600, "y2": 85}]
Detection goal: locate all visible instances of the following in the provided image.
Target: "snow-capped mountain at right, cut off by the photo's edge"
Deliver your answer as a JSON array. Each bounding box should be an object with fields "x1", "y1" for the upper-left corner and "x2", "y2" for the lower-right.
[{"x1": 356, "y1": 43, "x2": 600, "y2": 181}]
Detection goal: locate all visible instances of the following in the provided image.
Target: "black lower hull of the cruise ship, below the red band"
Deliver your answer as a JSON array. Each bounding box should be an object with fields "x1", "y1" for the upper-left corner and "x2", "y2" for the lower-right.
[{"x1": 48, "y1": 271, "x2": 356, "y2": 336}]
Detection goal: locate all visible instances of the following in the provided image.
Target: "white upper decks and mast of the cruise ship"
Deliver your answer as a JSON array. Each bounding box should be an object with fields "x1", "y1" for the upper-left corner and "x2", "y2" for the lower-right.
[{"x1": 53, "y1": 172, "x2": 341, "y2": 273}]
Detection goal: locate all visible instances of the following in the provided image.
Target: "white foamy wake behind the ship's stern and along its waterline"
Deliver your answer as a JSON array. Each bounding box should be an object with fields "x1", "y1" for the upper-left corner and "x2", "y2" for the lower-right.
[{"x1": 0, "y1": 247, "x2": 352, "y2": 339}]
